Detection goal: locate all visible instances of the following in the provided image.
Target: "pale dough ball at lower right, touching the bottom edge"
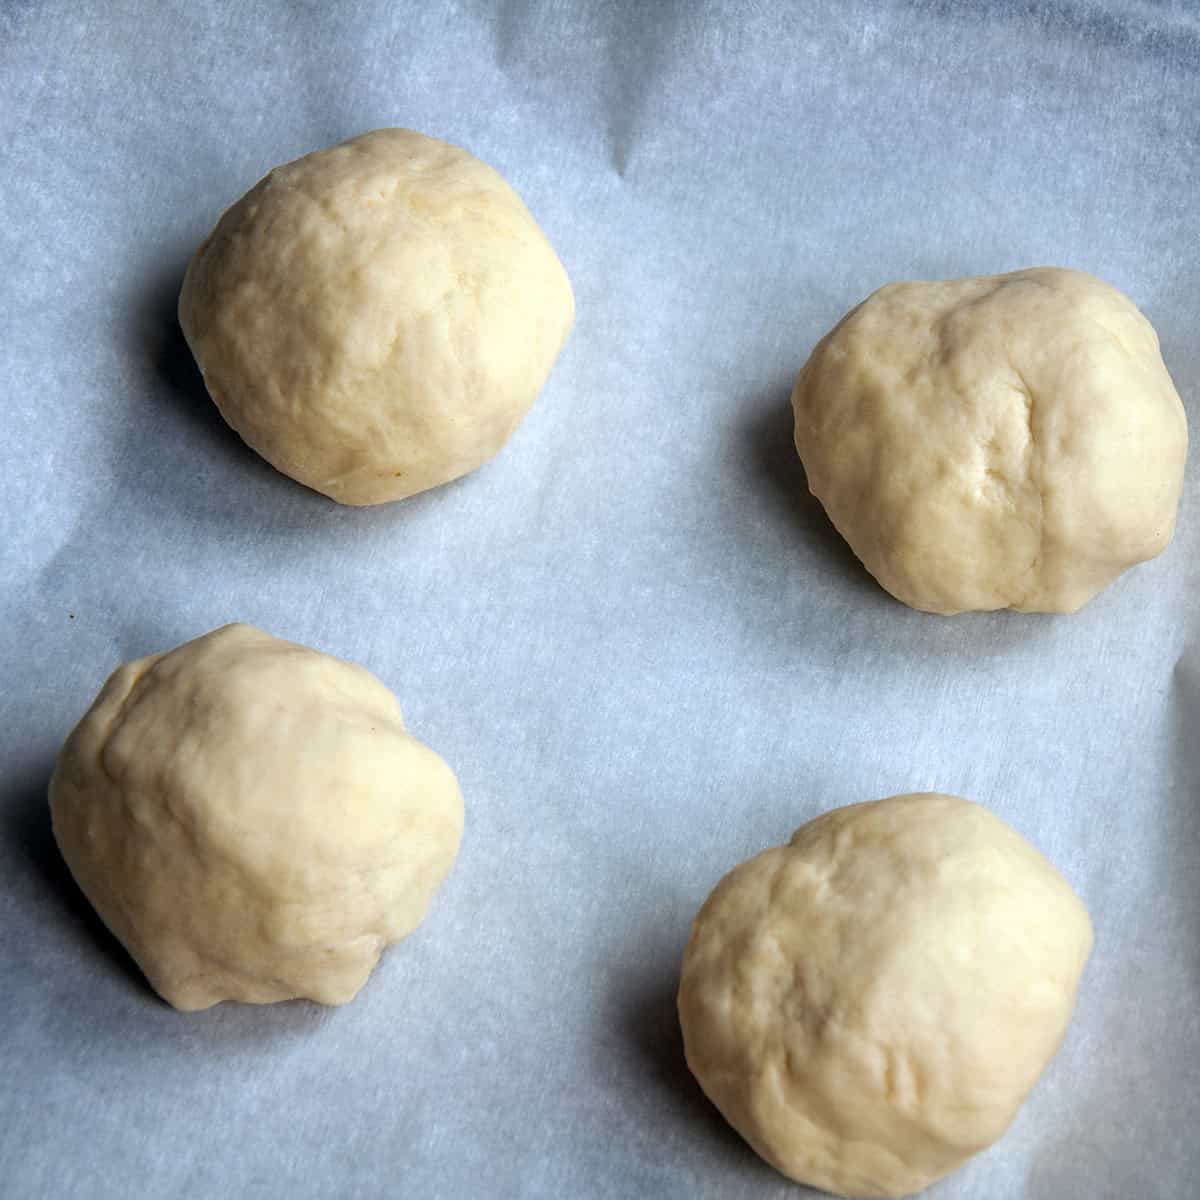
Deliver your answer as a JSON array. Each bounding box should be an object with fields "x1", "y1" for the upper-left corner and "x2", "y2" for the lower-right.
[{"x1": 679, "y1": 793, "x2": 1092, "y2": 1196}]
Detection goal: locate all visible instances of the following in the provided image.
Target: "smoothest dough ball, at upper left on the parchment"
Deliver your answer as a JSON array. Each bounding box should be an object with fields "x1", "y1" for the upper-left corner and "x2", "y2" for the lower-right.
[{"x1": 179, "y1": 130, "x2": 575, "y2": 504}]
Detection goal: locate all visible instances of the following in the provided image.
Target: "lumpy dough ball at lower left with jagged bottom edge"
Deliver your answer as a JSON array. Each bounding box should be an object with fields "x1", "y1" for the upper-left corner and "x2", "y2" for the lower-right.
[{"x1": 50, "y1": 625, "x2": 463, "y2": 1009}]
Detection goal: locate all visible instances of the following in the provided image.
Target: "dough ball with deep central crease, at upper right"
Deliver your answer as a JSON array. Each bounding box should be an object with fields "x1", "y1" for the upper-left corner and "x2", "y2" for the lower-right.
[{"x1": 792, "y1": 268, "x2": 1188, "y2": 613}]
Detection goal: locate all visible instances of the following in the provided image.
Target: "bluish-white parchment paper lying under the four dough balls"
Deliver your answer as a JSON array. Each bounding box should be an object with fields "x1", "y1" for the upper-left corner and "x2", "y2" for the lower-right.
[{"x1": 0, "y1": 0, "x2": 1200, "y2": 1200}]
